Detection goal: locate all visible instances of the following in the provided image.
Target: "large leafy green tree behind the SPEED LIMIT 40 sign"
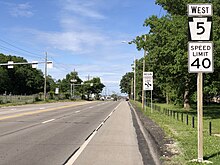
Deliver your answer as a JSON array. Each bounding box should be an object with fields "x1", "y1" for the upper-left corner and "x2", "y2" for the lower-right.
[{"x1": 127, "y1": 0, "x2": 220, "y2": 108}]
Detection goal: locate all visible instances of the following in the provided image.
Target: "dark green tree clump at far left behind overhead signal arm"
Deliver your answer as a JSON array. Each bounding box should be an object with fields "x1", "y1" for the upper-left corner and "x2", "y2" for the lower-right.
[{"x1": 0, "y1": 54, "x2": 44, "y2": 94}]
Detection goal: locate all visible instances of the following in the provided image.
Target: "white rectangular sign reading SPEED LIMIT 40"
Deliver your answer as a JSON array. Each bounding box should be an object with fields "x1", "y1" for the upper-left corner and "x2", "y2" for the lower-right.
[{"x1": 188, "y1": 42, "x2": 214, "y2": 73}]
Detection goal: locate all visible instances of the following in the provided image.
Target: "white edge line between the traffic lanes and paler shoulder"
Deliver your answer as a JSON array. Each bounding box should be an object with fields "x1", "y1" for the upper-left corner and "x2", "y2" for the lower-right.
[{"x1": 65, "y1": 102, "x2": 121, "y2": 165}]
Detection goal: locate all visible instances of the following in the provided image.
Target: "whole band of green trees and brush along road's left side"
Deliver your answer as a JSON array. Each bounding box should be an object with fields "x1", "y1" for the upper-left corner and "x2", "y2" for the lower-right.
[{"x1": 0, "y1": 53, "x2": 105, "y2": 104}]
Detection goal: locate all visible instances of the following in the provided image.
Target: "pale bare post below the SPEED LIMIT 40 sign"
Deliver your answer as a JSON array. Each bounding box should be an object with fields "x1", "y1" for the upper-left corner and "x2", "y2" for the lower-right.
[{"x1": 197, "y1": 73, "x2": 203, "y2": 162}]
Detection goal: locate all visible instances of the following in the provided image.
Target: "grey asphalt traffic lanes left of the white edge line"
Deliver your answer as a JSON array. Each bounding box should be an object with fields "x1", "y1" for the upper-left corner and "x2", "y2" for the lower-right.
[{"x1": 0, "y1": 101, "x2": 119, "y2": 165}]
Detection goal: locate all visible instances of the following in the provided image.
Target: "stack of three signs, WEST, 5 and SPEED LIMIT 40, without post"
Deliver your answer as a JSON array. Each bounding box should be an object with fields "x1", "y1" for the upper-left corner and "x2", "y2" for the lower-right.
[{"x1": 188, "y1": 4, "x2": 214, "y2": 73}]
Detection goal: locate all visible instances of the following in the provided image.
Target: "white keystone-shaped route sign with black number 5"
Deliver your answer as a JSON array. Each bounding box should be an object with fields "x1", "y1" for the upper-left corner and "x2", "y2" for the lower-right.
[{"x1": 189, "y1": 17, "x2": 212, "y2": 41}]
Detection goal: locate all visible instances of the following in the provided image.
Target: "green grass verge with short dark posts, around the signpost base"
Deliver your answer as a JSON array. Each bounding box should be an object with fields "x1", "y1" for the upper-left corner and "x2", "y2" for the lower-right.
[{"x1": 132, "y1": 102, "x2": 220, "y2": 165}]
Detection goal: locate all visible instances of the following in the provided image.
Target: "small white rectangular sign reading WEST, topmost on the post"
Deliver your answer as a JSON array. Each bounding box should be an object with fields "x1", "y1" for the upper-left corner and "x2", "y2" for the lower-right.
[{"x1": 188, "y1": 4, "x2": 213, "y2": 17}]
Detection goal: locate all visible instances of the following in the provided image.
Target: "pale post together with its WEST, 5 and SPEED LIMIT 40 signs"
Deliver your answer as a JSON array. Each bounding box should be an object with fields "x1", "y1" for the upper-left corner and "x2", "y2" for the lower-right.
[{"x1": 188, "y1": 4, "x2": 214, "y2": 162}]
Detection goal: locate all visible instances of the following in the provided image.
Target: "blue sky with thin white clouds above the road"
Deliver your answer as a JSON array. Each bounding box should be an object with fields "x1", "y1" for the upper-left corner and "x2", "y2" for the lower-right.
[{"x1": 0, "y1": 0, "x2": 163, "y2": 94}]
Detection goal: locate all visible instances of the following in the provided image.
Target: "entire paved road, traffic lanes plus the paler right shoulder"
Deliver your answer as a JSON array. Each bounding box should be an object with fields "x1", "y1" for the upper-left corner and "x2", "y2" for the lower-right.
[{"x1": 0, "y1": 101, "x2": 158, "y2": 165}]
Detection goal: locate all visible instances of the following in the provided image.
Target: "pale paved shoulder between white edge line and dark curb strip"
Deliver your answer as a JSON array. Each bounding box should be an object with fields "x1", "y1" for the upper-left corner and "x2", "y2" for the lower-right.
[{"x1": 74, "y1": 101, "x2": 143, "y2": 165}]
